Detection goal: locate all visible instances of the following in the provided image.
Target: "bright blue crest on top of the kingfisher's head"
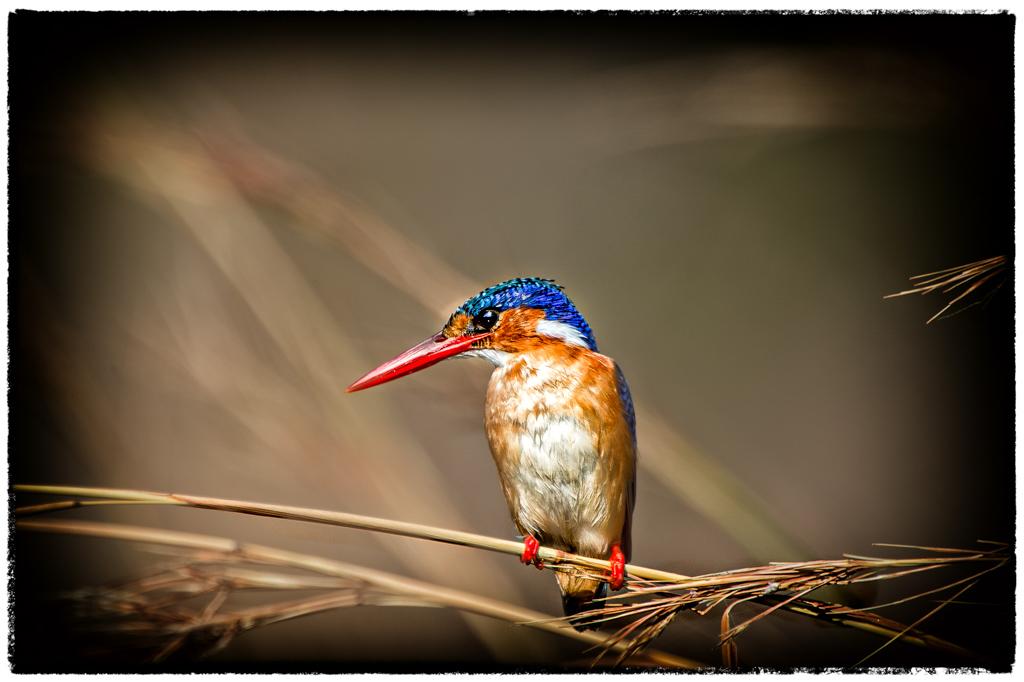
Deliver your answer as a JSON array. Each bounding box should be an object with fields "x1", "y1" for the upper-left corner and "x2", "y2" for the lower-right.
[{"x1": 456, "y1": 278, "x2": 597, "y2": 352}]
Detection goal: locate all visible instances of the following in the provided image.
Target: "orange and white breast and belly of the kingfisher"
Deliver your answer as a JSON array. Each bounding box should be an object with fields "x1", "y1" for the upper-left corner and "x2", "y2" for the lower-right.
[{"x1": 485, "y1": 343, "x2": 636, "y2": 558}]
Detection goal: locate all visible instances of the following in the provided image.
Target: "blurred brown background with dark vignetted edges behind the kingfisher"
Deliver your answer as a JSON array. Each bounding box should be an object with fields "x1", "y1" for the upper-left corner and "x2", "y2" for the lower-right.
[{"x1": 9, "y1": 12, "x2": 1014, "y2": 672}]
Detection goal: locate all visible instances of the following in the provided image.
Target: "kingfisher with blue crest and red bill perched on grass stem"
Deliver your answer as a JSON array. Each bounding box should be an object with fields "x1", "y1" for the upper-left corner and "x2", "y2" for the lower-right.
[{"x1": 347, "y1": 276, "x2": 637, "y2": 630}]
